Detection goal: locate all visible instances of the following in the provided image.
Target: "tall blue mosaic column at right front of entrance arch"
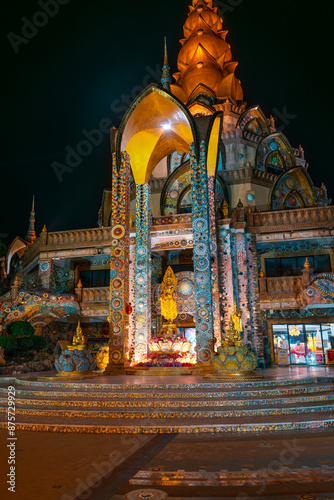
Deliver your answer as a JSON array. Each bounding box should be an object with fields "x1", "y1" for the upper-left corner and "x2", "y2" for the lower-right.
[{"x1": 190, "y1": 141, "x2": 214, "y2": 363}]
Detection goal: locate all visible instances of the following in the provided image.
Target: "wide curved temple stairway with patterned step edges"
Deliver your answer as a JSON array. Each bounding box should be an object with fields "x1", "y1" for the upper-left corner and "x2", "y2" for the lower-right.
[{"x1": 0, "y1": 377, "x2": 334, "y2": 433}]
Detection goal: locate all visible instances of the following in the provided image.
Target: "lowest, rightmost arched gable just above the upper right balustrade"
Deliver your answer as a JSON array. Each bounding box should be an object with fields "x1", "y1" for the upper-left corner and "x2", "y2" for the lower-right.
[{"x1": 270, "y1": 167, "x2": 317, "y2": 210}]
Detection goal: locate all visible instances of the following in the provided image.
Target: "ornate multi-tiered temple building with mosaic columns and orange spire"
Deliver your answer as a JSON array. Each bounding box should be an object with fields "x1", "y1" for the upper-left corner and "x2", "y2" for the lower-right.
[{"x1": 0, "y1": 0, "x2": 334, "y2": 372}]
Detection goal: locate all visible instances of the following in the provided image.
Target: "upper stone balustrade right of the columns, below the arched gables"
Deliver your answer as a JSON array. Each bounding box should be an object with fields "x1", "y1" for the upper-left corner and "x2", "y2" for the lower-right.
[{"x1": 247, "y1": 206, "x2": 334, "y2": 232}]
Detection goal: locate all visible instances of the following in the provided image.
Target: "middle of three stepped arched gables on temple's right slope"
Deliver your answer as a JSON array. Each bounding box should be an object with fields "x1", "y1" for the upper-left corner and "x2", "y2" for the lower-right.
[{"x1": 255, "y1": 132, "x2": 296, "y2": 174}]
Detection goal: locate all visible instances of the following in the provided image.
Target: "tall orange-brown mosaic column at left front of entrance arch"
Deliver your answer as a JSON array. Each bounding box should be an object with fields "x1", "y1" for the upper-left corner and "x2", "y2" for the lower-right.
[{"x1": 105, "y1": 153, "x2": 130, "y2": 373}]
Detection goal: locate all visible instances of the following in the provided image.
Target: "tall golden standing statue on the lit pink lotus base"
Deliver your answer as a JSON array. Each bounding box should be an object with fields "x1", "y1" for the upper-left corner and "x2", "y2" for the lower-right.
[{"x1": 158, "y1": 266, "x2": 179, "y2": 337}]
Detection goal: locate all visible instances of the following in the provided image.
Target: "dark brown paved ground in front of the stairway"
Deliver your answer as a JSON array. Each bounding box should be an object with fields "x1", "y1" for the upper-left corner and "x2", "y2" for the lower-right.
[{"x1": 0, "y1": 431, "x2": 334, "y2": 500}]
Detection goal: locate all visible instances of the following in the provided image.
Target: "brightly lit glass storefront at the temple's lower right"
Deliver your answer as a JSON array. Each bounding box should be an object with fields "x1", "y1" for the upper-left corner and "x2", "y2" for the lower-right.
[{"x1": 273, "y1": 323, "x2": 334, "y2": 365}]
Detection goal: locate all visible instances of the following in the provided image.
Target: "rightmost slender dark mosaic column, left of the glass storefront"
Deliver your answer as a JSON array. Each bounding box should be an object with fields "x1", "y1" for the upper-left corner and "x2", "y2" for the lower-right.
[{"x1": 246, "y1": 234, "x2": 264, "y2": 364}]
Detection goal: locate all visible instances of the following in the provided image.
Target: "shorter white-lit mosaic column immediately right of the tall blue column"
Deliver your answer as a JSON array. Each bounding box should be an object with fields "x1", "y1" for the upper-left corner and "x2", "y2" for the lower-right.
[{"x1": 218, "y1": 219, "x2": 235, "y2": 331}]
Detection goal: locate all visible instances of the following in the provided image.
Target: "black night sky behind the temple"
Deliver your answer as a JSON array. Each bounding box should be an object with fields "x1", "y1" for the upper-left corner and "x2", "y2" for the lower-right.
[{"x1": 0, "y1": 0, "x2": 334, "y2": 246}]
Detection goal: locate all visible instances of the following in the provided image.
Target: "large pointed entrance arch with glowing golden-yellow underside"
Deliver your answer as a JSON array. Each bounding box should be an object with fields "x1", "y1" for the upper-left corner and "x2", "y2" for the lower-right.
[{"x1": 116, "y1": 84, "x2": 198, "y2": 184}]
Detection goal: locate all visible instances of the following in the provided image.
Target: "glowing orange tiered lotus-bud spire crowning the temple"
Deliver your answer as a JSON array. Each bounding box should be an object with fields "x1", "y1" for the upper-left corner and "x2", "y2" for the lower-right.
[{"x1": 171, "y1": 0, "x2": 243, "y2": 109}]
